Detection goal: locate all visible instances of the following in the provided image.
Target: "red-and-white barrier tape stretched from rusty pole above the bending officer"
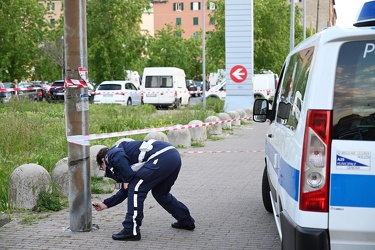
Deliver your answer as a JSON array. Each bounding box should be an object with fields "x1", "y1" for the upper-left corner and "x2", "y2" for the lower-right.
[{"x1": 67, "y1": 116, "x2": 252, "y2": 146}]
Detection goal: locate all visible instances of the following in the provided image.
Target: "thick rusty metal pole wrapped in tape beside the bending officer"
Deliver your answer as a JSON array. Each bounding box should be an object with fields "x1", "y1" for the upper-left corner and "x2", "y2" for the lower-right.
[{"x1": 64, "y1": 0, "x2": 92, "y2": 232}]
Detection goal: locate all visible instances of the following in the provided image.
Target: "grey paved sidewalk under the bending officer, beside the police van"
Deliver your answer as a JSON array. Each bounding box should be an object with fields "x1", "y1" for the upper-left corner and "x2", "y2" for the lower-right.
[{"x1": 0, "y1": 123, "x2": 280, "y2": 250}]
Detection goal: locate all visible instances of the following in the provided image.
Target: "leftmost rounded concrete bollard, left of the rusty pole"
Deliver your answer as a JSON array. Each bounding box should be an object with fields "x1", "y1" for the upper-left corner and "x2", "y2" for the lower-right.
[{"x1": 9, "y1": 163, "x2": 51, "y2": 209}]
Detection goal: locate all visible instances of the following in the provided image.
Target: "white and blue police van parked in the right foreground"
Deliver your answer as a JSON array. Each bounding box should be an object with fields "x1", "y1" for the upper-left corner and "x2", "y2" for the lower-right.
[{"x1": 253, "y1": 1, "x2": 375, "y2": 250}]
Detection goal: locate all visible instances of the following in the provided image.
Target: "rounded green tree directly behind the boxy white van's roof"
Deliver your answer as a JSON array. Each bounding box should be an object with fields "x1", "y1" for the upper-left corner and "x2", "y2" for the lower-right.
[{"x1": 147, "y1": 24, "x2": 202, "y2": 79}]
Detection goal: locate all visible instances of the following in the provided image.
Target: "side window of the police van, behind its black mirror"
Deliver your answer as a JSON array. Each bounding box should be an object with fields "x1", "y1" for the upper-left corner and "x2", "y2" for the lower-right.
[{"x1": 276, "y1": 47, "x2": 314, "y2": 131}]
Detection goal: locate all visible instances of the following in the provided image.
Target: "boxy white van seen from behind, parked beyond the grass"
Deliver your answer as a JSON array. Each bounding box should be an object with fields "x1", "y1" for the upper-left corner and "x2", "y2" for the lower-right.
[{"x1": 141, "y1": 67, "x2": 190, "y2": 107}]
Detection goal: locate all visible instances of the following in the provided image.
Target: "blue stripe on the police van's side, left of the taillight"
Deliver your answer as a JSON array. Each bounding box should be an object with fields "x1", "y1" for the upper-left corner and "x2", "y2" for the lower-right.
[{"x1": 266, "y1": 140, "x2": 300, "y2": 201}]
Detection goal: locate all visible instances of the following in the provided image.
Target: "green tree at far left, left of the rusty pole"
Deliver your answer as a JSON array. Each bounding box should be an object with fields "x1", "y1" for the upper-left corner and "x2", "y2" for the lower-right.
[{"x1": 0, "y1": 0, "x2": 47, "y2": 81}]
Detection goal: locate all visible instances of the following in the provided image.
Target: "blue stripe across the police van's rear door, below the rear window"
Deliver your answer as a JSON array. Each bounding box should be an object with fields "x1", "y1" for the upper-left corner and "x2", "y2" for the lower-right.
[{"x1": 330, "y1": 174, "x2": 375, "y2": 208}]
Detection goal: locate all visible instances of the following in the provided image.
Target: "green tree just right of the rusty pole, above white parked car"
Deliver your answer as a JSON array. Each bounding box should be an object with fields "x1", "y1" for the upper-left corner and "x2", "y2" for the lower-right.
[{"x1": 87, "y1": 0, "x2": 150, "y2": 83}]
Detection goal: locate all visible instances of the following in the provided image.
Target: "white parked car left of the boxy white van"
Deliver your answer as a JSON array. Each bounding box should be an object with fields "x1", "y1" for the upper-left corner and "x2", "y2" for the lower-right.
[{"x1": 94, "y1": 81, "x2": 142, "y2": 106}]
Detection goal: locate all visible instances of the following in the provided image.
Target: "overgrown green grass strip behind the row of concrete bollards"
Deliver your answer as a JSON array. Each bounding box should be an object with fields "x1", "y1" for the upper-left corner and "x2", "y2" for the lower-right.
[{"x1": 0, "y1": 100, "x2": 224, "y2": 211}]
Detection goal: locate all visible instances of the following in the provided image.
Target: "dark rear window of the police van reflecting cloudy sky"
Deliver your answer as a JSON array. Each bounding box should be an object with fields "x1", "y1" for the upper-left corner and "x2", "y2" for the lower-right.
[{"x1": 332, "y1": 40, "x2": 375, "y2": 141}]
